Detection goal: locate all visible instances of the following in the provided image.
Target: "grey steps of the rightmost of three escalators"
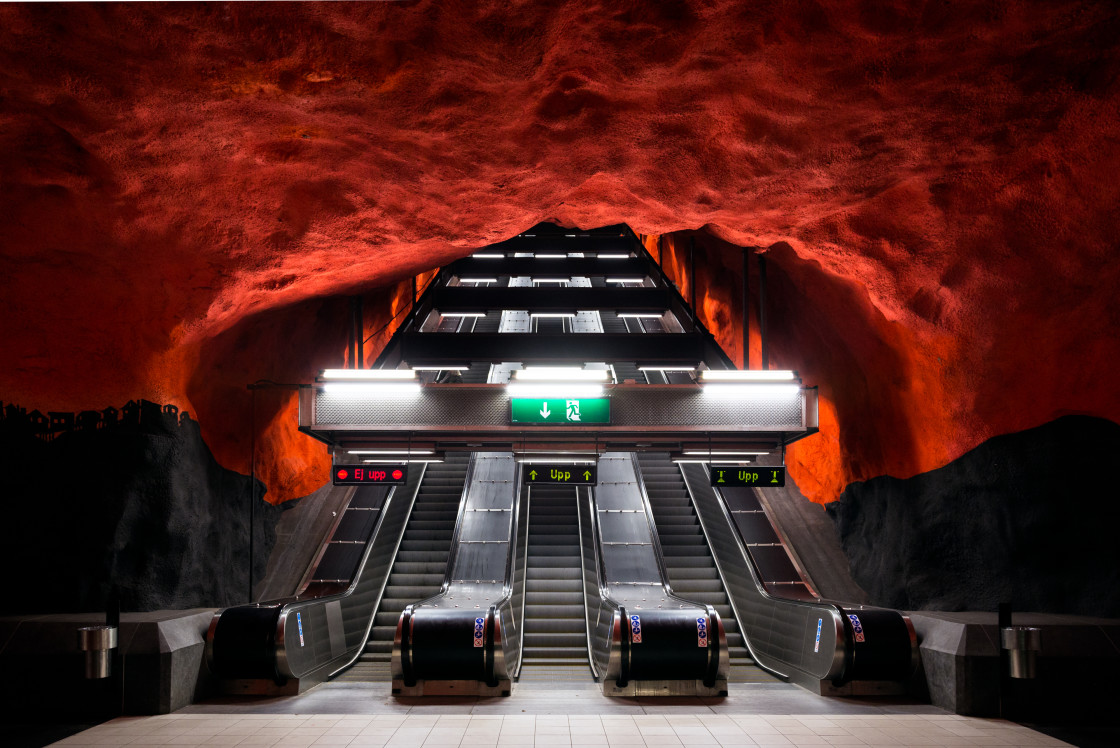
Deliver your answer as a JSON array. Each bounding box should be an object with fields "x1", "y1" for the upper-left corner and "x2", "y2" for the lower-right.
[{"x1": 637, "y1": 452, "x2": 778, "y2": 683}]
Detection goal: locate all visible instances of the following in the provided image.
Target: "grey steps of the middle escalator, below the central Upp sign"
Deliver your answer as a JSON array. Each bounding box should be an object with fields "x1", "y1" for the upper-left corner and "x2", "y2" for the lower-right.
[{"x1": 519, "y1": 486, "x2": 590, "y2": 684}]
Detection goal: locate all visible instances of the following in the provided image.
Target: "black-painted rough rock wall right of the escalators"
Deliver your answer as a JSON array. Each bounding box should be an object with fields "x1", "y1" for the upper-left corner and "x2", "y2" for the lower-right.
[{"x1": 828, "y1": 415, "x2": 1120, "y2": 618}]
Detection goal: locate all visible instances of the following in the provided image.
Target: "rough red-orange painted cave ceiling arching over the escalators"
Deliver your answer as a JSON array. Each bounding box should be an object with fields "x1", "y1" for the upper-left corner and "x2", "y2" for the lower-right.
[{"x1": 0, "y1": 0, "x2": 1120, "y2": 501}]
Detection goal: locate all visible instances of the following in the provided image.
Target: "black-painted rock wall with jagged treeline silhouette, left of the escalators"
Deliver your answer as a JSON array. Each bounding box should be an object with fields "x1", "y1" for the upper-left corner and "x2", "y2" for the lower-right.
[{"x1": 0, "y1": 403, "x2": 280, "y2": 614}]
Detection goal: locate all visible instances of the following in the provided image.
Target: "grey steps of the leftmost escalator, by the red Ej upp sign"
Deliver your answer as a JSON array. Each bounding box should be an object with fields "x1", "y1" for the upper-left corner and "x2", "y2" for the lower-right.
[{"x1": 337, "y1": 452, "x2": 470, "y2": 681}]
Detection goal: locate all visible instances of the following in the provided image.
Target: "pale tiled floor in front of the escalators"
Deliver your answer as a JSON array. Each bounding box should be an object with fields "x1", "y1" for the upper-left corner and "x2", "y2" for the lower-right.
[{"x1": 48, "y1": 683, "x2": 1068, "y2": 748}]
